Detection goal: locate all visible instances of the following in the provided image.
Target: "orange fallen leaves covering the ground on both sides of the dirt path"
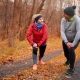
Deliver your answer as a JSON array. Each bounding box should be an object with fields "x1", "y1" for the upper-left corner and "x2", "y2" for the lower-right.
[{"x1": 0, "y1": 38, "x2": 80, "y2": 80}]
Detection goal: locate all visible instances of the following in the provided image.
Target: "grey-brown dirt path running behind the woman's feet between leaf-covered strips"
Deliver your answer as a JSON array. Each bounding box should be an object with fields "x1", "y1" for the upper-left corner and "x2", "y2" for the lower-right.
[{"x1": 0, "y1": 50, "x2": 62, "y2": 78}]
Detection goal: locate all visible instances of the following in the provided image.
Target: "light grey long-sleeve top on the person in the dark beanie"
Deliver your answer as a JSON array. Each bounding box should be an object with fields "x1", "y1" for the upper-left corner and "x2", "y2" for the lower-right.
[{"x1": 61, "y1": 15, "x2": 80, "y2": 46}]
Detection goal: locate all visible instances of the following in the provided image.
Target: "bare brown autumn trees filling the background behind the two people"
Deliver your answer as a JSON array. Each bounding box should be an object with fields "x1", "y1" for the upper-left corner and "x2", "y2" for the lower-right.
[{"x1": 0, "y1": 0, "x2": 80, "y2": 46}]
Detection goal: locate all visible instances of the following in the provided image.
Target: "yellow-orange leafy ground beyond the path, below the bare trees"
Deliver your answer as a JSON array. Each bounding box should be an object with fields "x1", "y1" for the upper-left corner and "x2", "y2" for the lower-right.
[{"x1": 0, "y1": 37, "x2": 62, "y2": 64}]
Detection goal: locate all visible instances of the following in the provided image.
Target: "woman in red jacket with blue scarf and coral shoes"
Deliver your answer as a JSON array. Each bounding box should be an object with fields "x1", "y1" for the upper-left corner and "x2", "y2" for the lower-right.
[{"x1": 26, "y1": 14, "x2": 48, "y2": 70}]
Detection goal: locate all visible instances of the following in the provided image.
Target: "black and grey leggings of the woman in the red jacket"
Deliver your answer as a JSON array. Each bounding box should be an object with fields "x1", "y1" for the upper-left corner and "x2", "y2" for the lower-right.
[{"x1": 33, "y1": 45, "x2": 46, "y2": 64}]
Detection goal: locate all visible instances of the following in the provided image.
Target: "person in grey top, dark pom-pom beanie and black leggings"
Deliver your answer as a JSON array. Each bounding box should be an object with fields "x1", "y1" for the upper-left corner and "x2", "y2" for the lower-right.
[{"x1": 61, "y1": 6, "x2": 80, "y2": 75}]
